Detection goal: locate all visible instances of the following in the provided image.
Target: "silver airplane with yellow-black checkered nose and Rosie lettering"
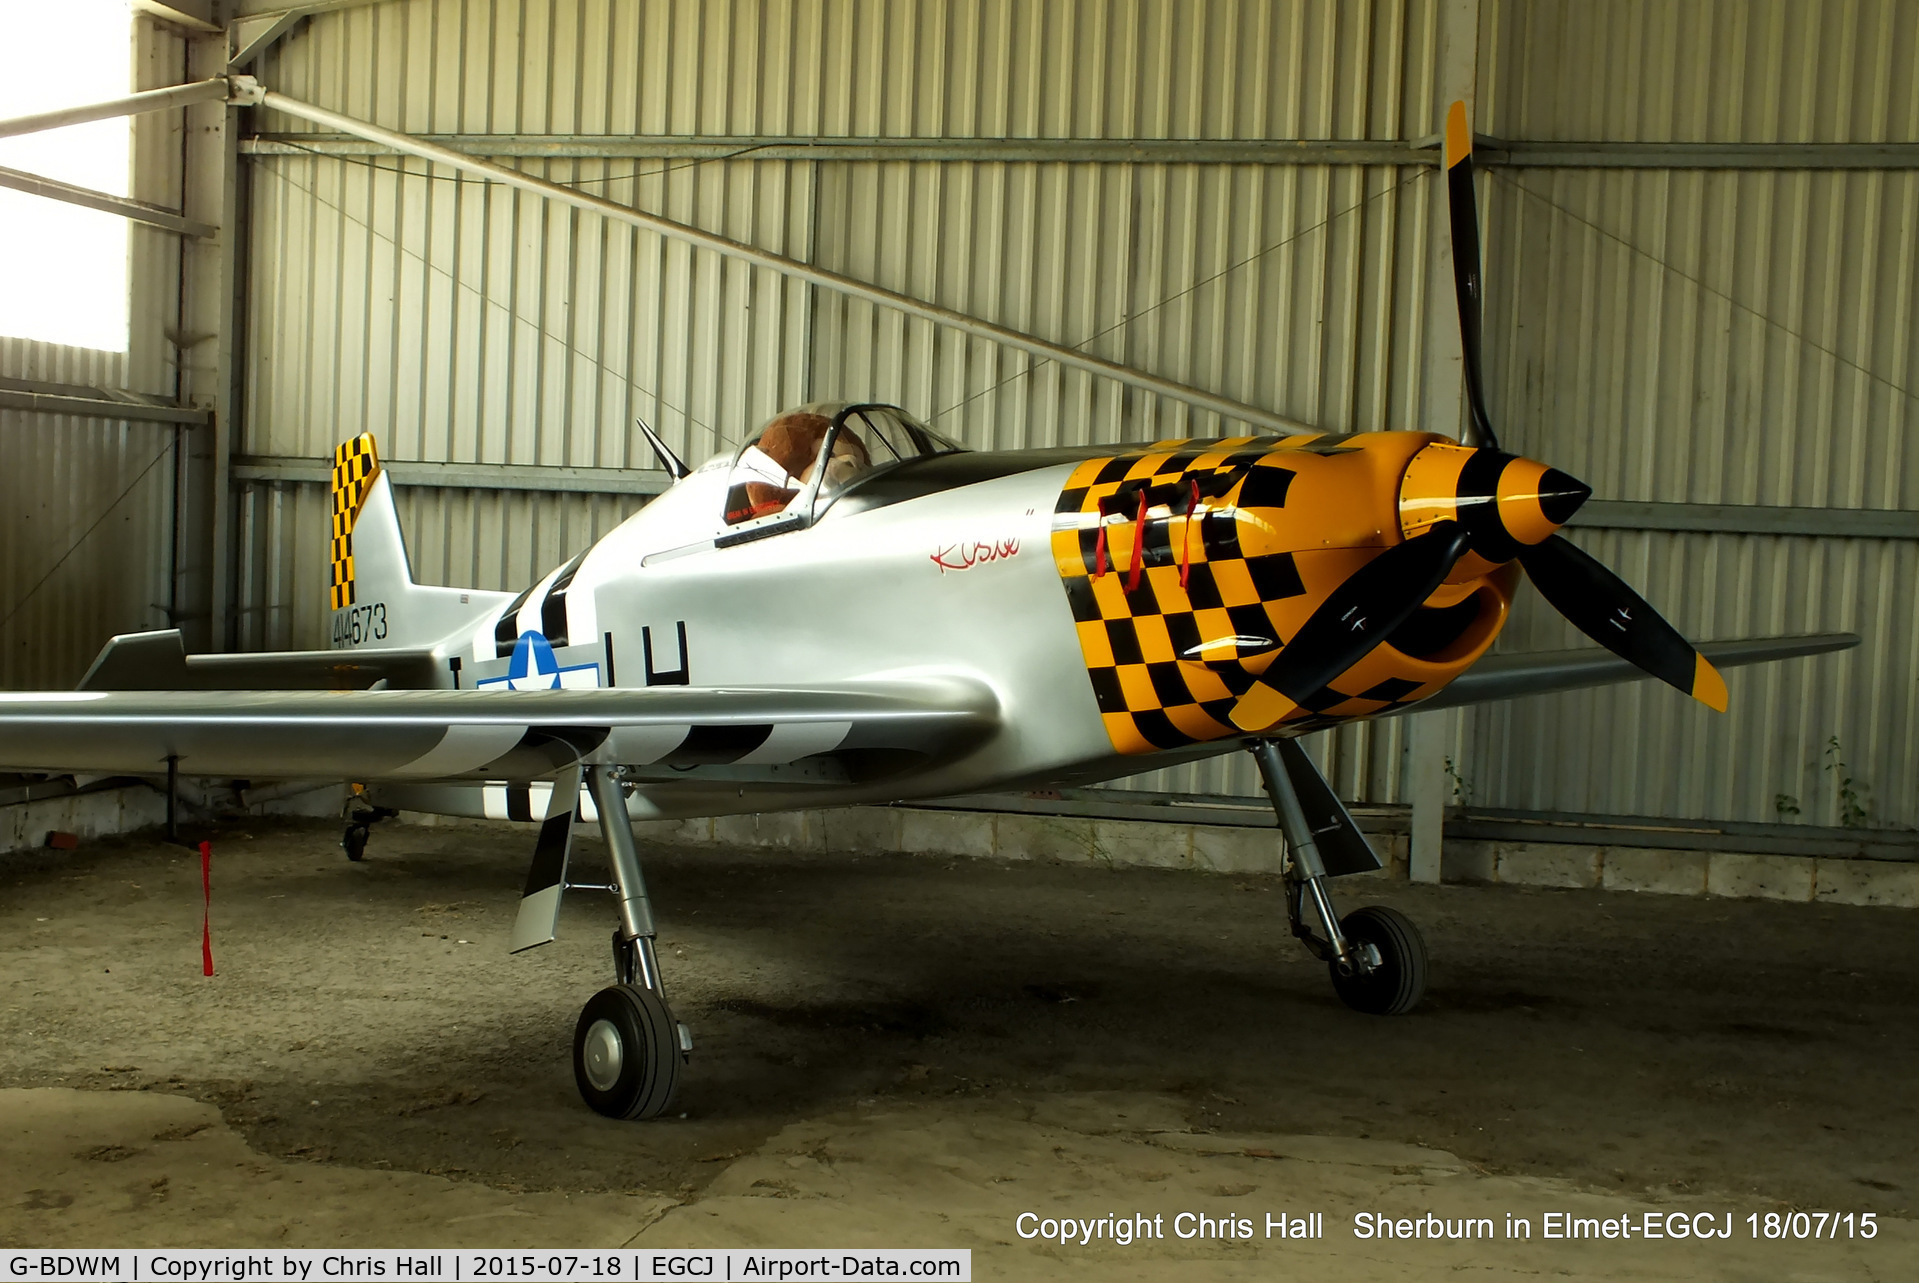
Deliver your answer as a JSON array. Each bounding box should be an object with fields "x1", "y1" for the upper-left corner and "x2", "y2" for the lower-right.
[{"x1": 0, "y1": 111, "x2": 1858, "y2": 1118}]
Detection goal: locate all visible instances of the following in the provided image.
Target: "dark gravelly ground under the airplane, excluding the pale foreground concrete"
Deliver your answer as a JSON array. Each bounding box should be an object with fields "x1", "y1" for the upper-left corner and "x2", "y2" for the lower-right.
[{"x1": 0, "y1": 821, "x2": 1919, "y2": 1242}]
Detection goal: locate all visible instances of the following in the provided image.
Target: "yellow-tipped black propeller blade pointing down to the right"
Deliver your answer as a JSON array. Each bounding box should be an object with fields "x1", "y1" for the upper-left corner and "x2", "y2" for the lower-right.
[{"x1": 1520, "y1": 535, "x2": 1725, "y2": 713}]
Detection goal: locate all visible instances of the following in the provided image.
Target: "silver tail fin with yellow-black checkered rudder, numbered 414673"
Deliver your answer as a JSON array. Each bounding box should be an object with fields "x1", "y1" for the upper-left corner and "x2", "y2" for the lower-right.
[{"x1": 328, "y1": 432, "x2": 512, "y2": 650}]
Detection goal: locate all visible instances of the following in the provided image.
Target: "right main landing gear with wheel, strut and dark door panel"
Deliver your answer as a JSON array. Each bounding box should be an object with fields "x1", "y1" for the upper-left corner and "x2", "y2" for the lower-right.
[{"x1": 1249, "y1": 740, "x2": 1426, "y2": 1016}]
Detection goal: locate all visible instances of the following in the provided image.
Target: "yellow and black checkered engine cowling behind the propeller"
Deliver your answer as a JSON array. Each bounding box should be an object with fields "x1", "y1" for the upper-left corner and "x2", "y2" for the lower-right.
[{"x1": 1054, "y1": 432, "x2": 1516, "y2": 754}]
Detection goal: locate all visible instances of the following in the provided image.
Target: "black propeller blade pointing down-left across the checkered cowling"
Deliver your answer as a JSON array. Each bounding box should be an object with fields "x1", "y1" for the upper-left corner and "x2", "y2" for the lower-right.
[{"x1": 1232, "y1": 522, "x2": 1470, "y2": 731}]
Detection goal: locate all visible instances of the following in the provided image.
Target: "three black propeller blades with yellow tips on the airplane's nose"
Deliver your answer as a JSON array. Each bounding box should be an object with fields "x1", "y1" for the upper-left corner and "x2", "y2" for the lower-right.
[{"x1": 1230, "y1": 102, "x2": 1725, "y2": 731}]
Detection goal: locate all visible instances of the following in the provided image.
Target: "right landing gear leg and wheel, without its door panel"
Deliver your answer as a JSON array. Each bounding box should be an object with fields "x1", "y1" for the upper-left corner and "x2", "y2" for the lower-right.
[{"x1": 1253, "y1": 740, "x2": 1426, "y2": 1016}]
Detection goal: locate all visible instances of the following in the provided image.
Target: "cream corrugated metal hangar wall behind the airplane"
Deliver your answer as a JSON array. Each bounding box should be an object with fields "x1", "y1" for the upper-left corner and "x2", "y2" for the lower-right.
[{"x1": 0, "y1": 0, "x2": 1919, "y2": 827}]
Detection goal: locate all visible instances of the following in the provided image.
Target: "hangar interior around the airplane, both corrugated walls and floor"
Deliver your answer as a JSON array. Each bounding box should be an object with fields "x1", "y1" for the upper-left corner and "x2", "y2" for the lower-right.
[{"x1": 0, "y1": 0, "x2": 1919, "y2": 1277}]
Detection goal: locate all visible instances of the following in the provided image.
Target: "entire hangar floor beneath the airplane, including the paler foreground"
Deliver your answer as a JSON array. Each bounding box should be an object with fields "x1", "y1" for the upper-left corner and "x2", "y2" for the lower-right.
[{"x1": 0, "y1": 821, "x2": 1919, "y2": 1279}]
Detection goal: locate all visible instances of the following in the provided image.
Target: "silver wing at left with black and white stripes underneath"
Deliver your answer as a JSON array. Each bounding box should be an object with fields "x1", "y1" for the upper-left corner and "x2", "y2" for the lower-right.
[{"x1": 0, "y1": 677, "x2": 1000, "y2": 781}]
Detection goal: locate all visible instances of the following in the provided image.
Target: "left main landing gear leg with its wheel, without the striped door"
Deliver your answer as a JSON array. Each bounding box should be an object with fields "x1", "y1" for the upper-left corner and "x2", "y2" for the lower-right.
[{"x1": 574, "y1": 767, "x2": 693, "y2": 1118}]
